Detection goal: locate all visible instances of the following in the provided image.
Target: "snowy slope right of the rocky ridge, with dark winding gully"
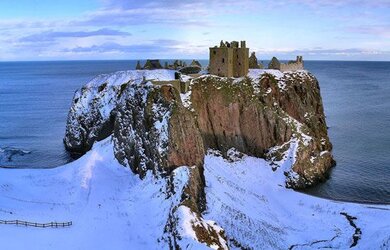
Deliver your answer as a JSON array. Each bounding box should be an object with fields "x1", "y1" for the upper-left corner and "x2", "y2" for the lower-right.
[{"x1": 204, "y1": 146, "x2": 390, "y2": 249}]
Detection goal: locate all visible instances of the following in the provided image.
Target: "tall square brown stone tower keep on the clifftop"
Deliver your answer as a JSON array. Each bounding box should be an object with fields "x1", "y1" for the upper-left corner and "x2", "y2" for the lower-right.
[{"x1": 209, "y1": 41, "x2": 249, "y2": 77}]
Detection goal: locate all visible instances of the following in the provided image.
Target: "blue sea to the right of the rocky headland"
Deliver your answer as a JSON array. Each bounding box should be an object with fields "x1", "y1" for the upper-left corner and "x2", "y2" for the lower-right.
[{"x1": 305, "y1": 61, "x2": 390, "y2": 204}]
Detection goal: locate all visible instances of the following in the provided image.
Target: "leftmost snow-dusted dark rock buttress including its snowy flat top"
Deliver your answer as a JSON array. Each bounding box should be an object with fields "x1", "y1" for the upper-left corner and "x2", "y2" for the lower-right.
[{"x1": 64, "y1": 70, "x2": 175, "y2": 154}]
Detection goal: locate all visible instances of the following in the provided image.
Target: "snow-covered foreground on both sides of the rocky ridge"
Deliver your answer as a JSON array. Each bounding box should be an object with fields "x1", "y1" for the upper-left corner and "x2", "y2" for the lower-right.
[{"x1": 0, "y1": 138, "x2": 390, "y2": 249}]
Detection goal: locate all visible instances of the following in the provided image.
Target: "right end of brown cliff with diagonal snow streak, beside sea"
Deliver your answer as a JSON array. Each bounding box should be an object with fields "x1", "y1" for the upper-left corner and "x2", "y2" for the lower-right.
[{"x1": 254, "y1": 71, "x2": 335, "y2": 188}]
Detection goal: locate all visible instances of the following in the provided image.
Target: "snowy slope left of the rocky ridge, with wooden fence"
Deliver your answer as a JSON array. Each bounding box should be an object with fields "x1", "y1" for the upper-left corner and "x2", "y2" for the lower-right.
[{"x1": 0, "y1": 138, "x2": 215, "y2": 249}]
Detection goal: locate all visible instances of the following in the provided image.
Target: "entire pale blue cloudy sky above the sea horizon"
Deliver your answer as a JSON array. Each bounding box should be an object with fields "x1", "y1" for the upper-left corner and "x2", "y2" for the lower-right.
[{"x1": 0, "y1": 0, "x2": 390, "y2": 61}]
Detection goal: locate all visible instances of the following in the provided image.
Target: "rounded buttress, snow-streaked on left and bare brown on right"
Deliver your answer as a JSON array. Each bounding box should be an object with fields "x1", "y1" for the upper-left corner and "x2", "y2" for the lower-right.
[{"x1": 113, "y1": 84, "x2": 204, "y2": 177}]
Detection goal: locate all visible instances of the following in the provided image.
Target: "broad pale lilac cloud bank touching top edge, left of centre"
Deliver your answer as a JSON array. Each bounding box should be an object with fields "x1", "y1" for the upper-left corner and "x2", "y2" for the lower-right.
[{"x1": 73, "y1": 0, "x2": 258, "y2": 28}]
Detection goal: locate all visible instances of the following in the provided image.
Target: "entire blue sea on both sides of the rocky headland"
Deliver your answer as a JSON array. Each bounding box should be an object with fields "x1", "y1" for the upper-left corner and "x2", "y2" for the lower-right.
[{"x1": 0, "y1": 60, "x2": 390, "y2": 204}]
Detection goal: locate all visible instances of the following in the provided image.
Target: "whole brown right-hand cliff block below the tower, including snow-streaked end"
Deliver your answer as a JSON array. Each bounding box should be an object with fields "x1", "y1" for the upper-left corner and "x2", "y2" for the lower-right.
[{"x1": 191, "y1": 70, "x2": 334, "y2": 188}]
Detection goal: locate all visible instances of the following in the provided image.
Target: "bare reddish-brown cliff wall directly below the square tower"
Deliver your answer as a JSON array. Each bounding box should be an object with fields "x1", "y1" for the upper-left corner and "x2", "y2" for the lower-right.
[{"x1": 191, "y1": 76, "x2": 292, "y2": 157}]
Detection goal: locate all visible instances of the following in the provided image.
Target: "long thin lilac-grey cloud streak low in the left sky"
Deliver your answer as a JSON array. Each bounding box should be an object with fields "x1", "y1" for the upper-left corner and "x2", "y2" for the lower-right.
[{"x1": 19, "y1": 28, "x2": 131, "y2": 42}]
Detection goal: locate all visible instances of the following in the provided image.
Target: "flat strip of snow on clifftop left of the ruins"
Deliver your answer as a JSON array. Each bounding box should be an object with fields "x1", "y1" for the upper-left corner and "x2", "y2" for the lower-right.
[{"x1": 86, "y1": 69, "x2": 176, "y2": 87}]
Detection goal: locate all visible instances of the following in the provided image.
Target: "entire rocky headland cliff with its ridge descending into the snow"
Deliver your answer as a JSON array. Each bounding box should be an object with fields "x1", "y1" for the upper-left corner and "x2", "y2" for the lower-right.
[{"x1": 64, "y1": 70, "x2": 333, "y2": 247}]
